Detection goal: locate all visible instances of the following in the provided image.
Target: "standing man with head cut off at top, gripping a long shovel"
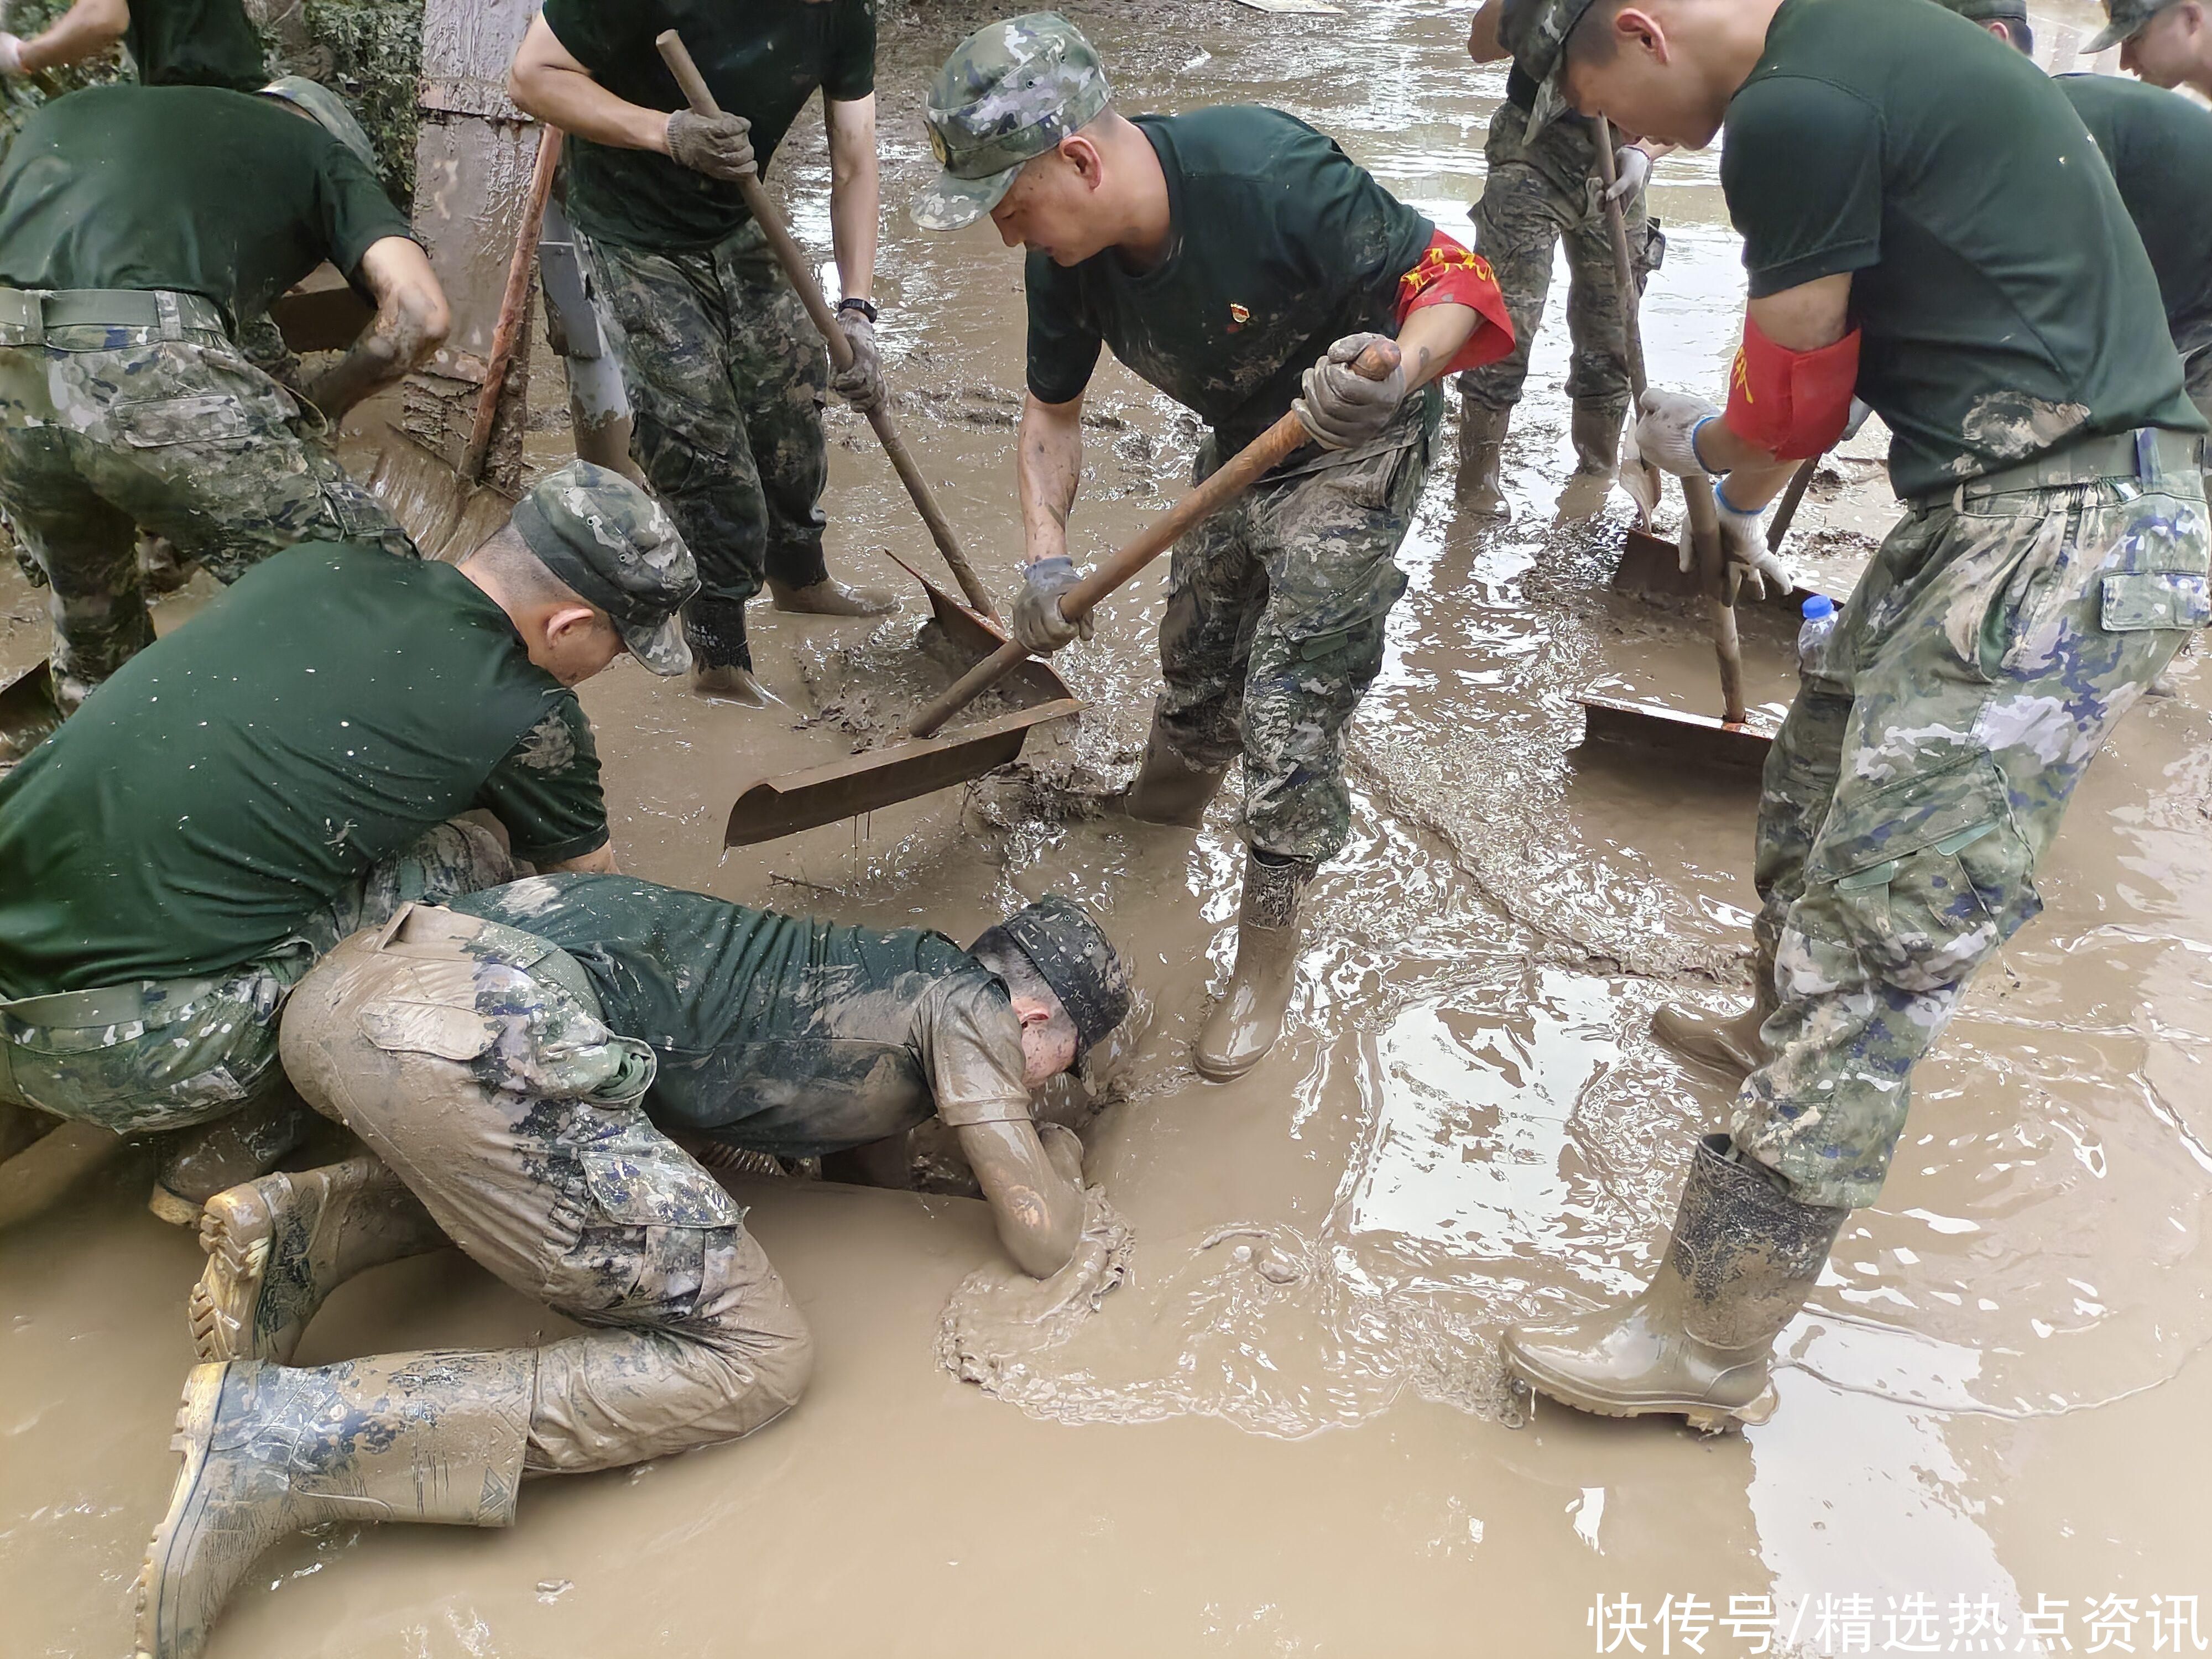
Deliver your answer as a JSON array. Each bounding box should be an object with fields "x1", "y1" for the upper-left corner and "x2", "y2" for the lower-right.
[{"x1": 511, "y1": 0, "x2": 891, "y2": 701}]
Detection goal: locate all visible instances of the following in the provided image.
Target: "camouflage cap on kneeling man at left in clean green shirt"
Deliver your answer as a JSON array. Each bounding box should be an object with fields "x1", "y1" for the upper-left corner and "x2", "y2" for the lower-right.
[{"x1": 513, "y1": 460, "x2": 699, "y2": 675}]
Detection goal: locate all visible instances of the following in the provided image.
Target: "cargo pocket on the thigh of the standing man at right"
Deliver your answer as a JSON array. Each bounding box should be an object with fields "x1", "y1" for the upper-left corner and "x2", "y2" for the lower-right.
[{"x1": 1805, "y1": 754, "x2": 2042, "y2": 991}]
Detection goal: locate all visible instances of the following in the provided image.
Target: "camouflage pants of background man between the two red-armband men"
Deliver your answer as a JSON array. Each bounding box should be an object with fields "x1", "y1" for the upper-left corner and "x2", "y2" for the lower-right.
[{"x1": 1458, "y1": 104, "x2": 1663, "y2": 411}]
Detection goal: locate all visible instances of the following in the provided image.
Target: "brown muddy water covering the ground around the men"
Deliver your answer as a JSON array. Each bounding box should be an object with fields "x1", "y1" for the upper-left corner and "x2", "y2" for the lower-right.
[{"x1": 0, "y1": 4, "x2": 2212, "y2": 1657}]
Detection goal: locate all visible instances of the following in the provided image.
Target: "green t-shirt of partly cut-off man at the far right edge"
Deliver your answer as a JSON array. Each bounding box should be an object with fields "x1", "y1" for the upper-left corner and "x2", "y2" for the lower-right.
[{"x1": 2057, "y1": 75, "x2": 2212, "y2": 354}]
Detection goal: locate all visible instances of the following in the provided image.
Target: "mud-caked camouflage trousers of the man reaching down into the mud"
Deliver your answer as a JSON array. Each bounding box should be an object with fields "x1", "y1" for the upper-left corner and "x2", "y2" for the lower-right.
[{"x1": 283, "y1": 905, "x2": 814, "y2": 1473}]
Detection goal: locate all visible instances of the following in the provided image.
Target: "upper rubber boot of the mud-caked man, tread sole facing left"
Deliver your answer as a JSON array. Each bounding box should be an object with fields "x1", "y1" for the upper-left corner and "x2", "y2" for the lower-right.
[{"x1": 188, "y1": 1152, "x2": 447, "y2": 1365}]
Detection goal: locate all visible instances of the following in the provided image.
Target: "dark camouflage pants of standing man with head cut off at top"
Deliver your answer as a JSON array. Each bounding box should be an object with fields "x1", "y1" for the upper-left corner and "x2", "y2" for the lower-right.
[{"x1": 591, "y1": 221, "x2": 830, "y2": 668}]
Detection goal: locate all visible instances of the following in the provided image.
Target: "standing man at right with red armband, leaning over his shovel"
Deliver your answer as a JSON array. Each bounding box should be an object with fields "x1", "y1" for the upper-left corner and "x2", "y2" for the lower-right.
[{"x1": 1504, "y1": 0, "x2": 2212, "y2": 1427}]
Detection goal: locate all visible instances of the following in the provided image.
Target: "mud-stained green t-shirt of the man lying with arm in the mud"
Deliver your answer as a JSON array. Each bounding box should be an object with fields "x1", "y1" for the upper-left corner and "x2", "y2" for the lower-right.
[{"x1": 453, "y1": 876, "x2": 1029, "y2": 1157}]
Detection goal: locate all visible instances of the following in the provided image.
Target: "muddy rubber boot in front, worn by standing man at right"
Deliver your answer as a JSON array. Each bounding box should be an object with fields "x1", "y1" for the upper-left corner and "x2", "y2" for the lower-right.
[{"x1": 1504, "y1": 1135, "x2": 1849, "y2": 1431}]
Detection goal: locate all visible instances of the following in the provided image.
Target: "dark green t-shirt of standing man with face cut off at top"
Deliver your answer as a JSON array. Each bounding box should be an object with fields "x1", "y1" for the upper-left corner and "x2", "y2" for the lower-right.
[{"x1": 544, "y1": 0, "x2": 876, "y2": 252}]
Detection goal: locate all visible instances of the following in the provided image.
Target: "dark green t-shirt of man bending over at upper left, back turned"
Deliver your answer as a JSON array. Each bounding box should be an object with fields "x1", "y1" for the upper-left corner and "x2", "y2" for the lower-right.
[{"x1": 0, "y1": 86, "x2": 411, "y2": 323}]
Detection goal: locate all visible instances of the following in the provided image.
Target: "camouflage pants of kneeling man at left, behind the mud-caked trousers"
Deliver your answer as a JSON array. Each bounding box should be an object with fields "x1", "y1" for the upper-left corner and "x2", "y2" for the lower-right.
[{"x1": 0, "y1": 821, "x2": 513, "y2": 1135}]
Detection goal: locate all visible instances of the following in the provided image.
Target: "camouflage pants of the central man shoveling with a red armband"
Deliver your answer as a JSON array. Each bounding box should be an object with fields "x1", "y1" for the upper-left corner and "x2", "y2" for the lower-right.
[{"x1": 1155, "y1": 407, "x2": 1442, "y2": 863}]
